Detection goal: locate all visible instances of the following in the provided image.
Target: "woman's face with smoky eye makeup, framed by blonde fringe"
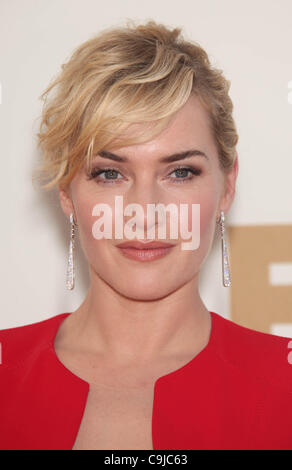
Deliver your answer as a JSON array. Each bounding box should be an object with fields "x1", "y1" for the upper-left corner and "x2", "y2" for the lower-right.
[{"x1": 60, "y1": 96, "x2": 238, "y2": 300}]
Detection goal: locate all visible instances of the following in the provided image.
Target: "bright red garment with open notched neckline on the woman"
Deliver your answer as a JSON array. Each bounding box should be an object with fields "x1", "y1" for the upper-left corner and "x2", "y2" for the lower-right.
[{"x1": 0, "y1": 312, "x2": 292, "y2": 450}]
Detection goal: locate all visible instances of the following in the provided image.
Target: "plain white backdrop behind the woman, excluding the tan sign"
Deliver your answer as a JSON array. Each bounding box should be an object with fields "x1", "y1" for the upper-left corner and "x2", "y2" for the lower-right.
[{"x1": 0, "y1": 0, "x2": 292, "y2": 328}]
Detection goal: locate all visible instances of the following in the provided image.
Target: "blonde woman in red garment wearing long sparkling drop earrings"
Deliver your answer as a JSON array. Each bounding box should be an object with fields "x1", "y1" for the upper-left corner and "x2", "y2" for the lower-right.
[{"x1": 0, "y1": 21, "x2": 292, "y2": 449}]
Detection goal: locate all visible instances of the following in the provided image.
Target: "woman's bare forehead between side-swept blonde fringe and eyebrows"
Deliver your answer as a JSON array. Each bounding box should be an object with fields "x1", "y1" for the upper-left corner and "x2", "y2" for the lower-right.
[{"x1": 108, "y1": 95, "x2": 216, "y2": 162}]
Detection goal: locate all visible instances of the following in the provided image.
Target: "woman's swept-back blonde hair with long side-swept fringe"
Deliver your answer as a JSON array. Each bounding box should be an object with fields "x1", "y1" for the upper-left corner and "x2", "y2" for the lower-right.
[{"x1": 33, "y1": 20, "x2": 238, "y2": 189}]
